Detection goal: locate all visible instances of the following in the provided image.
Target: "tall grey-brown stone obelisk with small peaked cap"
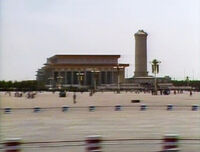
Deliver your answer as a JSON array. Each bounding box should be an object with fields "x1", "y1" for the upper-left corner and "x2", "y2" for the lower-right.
[{"x1": 134, "y1": 30, "x2": 148, "y2": 77}]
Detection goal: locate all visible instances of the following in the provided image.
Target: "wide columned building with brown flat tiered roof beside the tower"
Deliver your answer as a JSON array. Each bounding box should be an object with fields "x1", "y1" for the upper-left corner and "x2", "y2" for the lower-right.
[{"x1": 36, "y1": 55, "x2": 129, "y2": 88}]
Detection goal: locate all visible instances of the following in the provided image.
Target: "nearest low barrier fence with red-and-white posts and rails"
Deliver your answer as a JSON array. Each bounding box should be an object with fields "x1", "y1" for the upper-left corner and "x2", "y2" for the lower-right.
[{"x1": 0, "y1": 137, "x2": 200, "y2": 152}]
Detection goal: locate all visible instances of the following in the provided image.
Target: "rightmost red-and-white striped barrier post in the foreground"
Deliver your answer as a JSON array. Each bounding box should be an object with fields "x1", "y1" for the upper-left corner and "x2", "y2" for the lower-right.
[{"x1": 163, "y1": 134, "x2": 179, "y2": 152}]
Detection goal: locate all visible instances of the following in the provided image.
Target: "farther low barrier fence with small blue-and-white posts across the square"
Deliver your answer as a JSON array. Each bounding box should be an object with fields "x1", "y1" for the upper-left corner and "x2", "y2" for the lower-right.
[{"x1": 0, "y1": 104, "x2": 199, "y2": 114}]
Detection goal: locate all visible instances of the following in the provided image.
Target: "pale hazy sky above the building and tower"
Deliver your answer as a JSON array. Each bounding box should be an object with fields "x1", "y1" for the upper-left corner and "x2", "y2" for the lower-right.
[{"x1": 0, "y1": 0, "x2": 200, "y2": 80}]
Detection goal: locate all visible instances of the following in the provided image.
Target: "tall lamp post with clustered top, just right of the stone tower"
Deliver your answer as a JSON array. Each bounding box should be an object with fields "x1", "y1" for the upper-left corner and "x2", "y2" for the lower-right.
[{"x1": 150, "y1": 59, "x2": 161, "y2": 95}]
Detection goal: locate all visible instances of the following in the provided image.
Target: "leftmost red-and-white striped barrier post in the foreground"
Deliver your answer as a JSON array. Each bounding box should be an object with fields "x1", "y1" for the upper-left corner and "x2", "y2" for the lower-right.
[{"x1": 4, "y1": 138, "x2": 21, "y2": 152}]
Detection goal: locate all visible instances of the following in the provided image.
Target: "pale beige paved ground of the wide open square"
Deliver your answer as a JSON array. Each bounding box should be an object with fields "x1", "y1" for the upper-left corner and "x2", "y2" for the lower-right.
[{"x1": 0, "y1": 92, "x2": 200, "y2": 152}]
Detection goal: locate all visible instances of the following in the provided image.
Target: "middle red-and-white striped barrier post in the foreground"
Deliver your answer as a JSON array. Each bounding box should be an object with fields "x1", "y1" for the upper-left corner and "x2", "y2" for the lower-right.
[{"x1": 86, "y1": 135, "x2": 102, "y2": 152}]
